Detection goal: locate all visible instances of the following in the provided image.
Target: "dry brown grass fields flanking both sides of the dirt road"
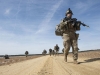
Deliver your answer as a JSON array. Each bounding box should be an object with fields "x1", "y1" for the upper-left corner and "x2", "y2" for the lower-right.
[{"x1": 0, "y1": 50, "x2": 100, "y2": 66}]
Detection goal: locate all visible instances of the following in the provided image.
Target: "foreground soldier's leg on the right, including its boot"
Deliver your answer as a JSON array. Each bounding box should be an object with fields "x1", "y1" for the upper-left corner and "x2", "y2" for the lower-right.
[{"x1": 72, "y1": 40, "x2": 79, "y2": 64}]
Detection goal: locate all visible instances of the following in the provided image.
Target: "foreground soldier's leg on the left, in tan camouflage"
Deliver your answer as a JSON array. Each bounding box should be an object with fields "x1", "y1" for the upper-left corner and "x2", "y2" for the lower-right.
[{"x1": 63, "y1": 40, "x2": 70, "y2": 62}]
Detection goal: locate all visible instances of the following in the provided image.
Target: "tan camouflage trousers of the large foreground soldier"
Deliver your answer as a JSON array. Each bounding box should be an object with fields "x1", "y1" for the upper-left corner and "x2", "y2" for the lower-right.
[{"x1": 63, "y1": 32, "x2": 78, "y2": 60}]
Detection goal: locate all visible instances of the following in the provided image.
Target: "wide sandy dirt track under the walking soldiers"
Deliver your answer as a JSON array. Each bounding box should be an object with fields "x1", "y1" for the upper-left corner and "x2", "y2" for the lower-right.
[{"x1": 0, "y1": 56, "x2": 100, "y2": 75}]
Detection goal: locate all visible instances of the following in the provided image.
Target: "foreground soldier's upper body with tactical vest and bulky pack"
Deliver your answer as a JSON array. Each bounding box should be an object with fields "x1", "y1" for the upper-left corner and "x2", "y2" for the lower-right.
[{"x1": 55, "y1": 17, "x2": 80, "y2": 36}]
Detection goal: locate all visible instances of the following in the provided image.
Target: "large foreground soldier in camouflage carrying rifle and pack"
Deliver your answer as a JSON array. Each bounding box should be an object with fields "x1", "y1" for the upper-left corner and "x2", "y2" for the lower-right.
[{"x1": 55, "y1": 8, "x2": 89, "y2": 64}]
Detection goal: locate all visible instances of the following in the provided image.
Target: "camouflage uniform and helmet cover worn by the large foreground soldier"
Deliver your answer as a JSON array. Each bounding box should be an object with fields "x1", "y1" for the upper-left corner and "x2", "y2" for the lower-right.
[{"x1": 60, "y1": 9, "x2": 78, "y2": 63}]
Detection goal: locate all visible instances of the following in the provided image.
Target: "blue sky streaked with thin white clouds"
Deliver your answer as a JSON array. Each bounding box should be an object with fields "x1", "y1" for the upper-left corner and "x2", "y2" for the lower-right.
[{"x1": 0, "y1": 0, "x2": 100, "y2": 55}]
